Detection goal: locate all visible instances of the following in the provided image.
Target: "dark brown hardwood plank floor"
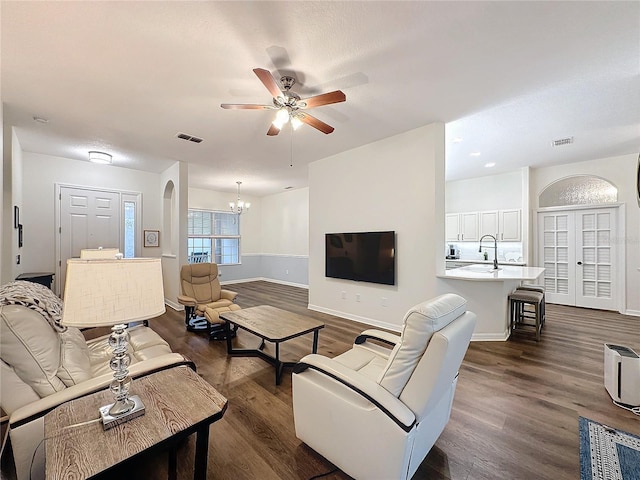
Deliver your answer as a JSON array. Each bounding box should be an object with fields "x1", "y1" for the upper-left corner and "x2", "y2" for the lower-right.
[{"x1": 2, "y1": 282, "x2": 640, "y2": 480}]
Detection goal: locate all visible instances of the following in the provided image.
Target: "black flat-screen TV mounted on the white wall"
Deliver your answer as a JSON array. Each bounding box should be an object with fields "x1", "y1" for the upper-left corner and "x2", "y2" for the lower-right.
[{"x1": 325, "y1": 232, "x2": 396, "y2": 285}]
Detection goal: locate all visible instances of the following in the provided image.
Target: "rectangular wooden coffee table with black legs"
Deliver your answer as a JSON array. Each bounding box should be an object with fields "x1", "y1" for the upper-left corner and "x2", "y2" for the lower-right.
[{"x1": 220, "y1": 305, "x2": 324, "y2": 385}]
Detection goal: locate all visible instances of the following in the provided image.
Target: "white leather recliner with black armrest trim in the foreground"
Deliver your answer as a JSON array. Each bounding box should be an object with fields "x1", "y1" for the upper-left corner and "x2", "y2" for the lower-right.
[{"x1": 293, "y1": 294, "x2": 476, "y2": 480}]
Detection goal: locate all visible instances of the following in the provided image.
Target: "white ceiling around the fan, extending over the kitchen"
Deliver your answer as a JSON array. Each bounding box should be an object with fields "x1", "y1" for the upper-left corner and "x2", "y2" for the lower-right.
[{"x1": 0, "y1": 1, "x2": 640, "y2": 196}]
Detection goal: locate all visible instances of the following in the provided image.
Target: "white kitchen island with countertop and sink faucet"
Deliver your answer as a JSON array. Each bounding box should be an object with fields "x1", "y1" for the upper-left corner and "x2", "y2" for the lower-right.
[{"x1": 437, "y1": 263, "x2": 544, "y2": 341}]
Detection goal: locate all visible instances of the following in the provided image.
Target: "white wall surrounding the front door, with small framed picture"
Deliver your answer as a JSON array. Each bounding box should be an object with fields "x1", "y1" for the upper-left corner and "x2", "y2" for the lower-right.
[{"x1": 20, "y1": 152, "x2": 161, "y2": 290}]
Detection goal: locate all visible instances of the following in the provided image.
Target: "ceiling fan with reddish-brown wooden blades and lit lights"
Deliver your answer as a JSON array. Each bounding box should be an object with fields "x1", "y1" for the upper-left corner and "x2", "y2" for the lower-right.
[{"x1": 220, "y1": 68, "x2": 347, "y2": 136}]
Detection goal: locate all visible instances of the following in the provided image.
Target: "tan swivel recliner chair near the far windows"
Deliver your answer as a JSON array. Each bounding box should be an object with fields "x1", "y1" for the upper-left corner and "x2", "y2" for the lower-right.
[{"x1": 178, "y1": 263, "x2": 240, "y2": 340}]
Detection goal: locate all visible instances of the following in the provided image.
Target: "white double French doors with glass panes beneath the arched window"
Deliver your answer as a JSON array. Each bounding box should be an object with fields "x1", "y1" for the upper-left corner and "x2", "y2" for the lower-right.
[{"x1": 538, "y1": 208, "x2": 618, "y2": 310}]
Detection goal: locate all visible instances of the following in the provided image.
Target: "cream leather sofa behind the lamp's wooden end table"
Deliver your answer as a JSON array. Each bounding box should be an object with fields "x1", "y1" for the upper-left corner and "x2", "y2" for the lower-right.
[{"x1": 0, "y1": 305, "x2": 193, "y2": 480}]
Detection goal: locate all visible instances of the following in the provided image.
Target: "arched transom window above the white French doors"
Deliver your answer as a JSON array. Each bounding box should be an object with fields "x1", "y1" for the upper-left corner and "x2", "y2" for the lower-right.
[{"x1": 539, "y1": 175, "x2": 618, "y2": 207}]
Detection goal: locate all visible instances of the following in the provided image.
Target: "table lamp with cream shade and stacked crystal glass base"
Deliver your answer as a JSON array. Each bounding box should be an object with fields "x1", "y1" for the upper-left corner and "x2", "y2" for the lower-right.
[{"x1": 62, "y1": 258, "x2": 165, "y2": 430}]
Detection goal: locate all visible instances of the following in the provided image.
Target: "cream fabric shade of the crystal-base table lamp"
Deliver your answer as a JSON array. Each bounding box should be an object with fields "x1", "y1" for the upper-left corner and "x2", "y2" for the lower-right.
[{"x1": 62, "y1": 258, "x2": 165, "y2": 327}]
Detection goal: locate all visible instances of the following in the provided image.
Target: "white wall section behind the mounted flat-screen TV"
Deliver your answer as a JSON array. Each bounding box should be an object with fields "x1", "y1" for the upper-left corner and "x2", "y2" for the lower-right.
[{"x1": 309, "y1": 124, "x2": 444, "y2": 329}]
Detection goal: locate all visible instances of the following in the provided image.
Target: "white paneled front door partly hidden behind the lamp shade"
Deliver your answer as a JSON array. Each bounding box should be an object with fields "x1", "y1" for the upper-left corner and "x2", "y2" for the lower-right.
[{"x1": 56, "y1": 187, "x2": 121, "y2": 294}]
